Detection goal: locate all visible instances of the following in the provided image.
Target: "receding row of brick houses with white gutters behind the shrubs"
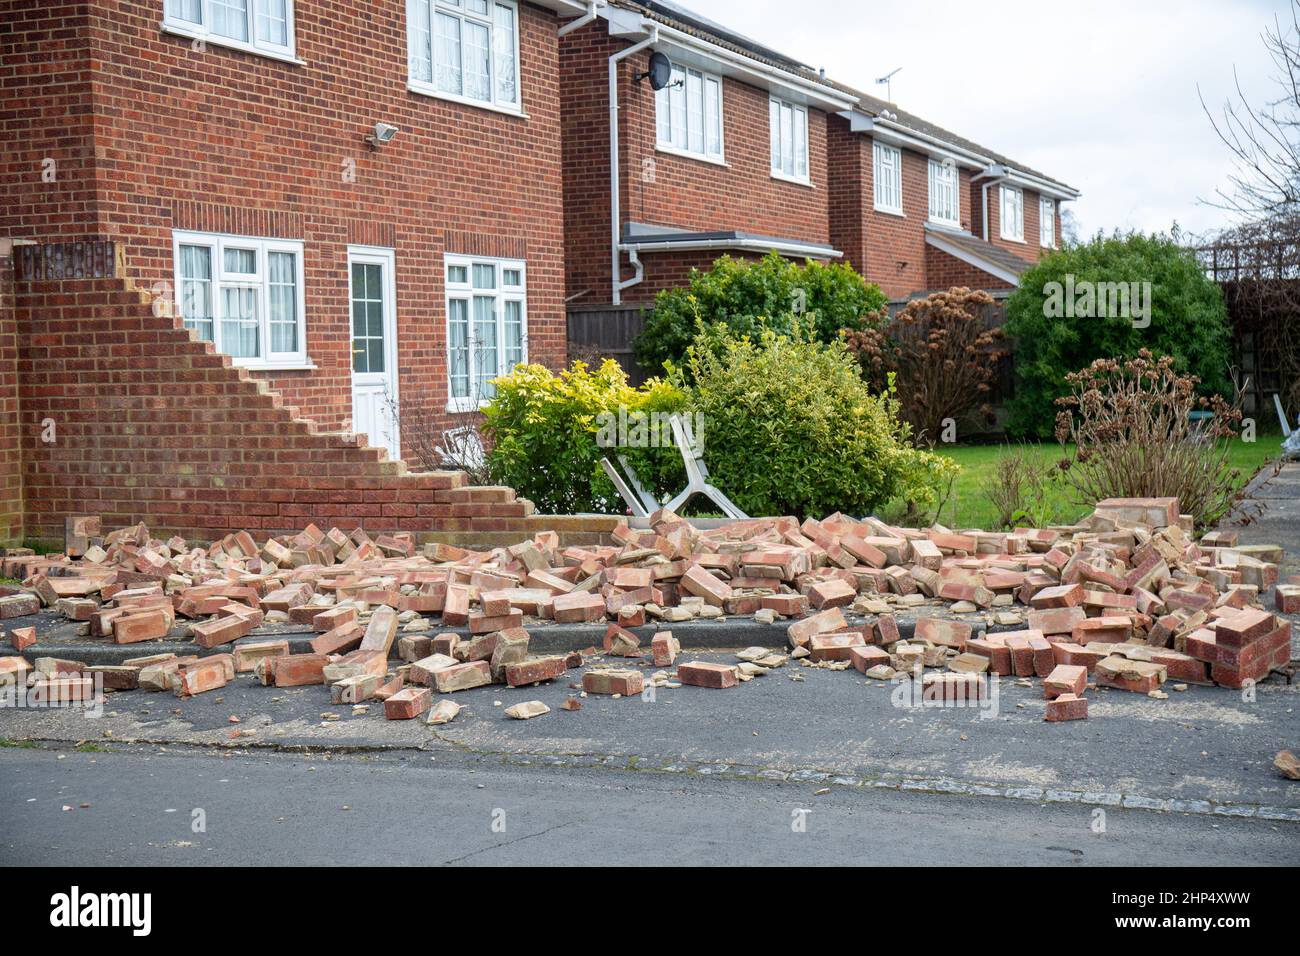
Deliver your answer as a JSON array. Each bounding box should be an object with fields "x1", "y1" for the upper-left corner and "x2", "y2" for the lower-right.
[{"x1": 560, "y1": 0, "x2": 1079, "y2": 308}]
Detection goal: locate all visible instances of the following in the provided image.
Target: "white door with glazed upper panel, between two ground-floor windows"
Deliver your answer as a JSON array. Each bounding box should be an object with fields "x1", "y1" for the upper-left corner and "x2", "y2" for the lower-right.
[{"x1": 347, "y1": 246, "x2": 402, "y2": 460}]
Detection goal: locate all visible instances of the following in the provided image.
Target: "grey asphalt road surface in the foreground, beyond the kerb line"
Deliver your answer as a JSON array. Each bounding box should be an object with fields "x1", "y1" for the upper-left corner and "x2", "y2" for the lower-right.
[{"x1": 0, "y1": 747, "x2": 1300, "y2": 866}]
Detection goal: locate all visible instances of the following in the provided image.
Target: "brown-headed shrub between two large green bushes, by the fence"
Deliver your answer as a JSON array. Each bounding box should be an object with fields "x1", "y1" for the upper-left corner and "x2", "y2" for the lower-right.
[{"x1": 846, "y1": 287, "x2": 1004, "y2": 447}]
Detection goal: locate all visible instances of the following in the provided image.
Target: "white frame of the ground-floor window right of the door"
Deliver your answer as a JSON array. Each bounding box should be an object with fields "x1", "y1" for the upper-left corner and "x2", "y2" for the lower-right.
[{"x1": 442, "y1": 252, "x2": 528, "y2": 412}]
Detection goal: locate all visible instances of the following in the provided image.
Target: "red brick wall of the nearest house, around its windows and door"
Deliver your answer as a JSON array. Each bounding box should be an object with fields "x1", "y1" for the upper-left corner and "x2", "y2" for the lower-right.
[{"x1": 0, "y1": 0, "x2": 566, "y2": 452}]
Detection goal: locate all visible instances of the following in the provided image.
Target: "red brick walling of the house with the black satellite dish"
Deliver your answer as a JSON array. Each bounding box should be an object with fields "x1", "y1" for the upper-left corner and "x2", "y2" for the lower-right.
[{"x1": 560, "y1": 21, "x2": 831, "y2": 304}]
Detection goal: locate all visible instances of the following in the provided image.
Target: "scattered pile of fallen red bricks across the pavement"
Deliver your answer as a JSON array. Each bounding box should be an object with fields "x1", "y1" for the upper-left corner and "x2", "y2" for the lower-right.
[{"x1": 0, "y1": 498, "x2": 1300, "y2": 723}]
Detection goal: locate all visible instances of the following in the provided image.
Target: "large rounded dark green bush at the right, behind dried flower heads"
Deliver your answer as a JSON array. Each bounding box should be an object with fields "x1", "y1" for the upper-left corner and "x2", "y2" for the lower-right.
[{"x1": 1005, "y1": 233, "x2": 1231, "y2": 438}]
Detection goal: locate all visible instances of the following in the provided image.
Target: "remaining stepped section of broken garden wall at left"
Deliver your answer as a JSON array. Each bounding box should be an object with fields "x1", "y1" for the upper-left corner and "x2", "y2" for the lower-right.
[{"x1": 11, "y1": 278, "x2": 629, "y2": 546}]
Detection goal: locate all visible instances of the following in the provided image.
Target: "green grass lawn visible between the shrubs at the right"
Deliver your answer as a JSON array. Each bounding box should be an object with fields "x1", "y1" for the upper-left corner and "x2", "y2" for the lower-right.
[{"x1": 883, "y1": 434, "x2": 1281, "y2": 531}]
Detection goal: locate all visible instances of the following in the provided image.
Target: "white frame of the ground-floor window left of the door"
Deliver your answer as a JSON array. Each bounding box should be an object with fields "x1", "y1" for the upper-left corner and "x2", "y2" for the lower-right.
[{"x1": 172, "y1": 229, "x2": 313, "y2": 369}]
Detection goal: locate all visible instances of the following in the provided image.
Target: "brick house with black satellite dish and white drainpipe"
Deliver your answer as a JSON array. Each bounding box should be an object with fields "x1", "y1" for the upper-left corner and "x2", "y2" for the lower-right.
[{"x1": 560, "y1": 0, "x2": 855, "y2": 306}]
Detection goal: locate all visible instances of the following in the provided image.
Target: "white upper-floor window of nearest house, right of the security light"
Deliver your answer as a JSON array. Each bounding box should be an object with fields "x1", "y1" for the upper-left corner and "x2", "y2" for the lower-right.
[{"x1": 407, "y1": 0, "x2": 523, "y2": 113}]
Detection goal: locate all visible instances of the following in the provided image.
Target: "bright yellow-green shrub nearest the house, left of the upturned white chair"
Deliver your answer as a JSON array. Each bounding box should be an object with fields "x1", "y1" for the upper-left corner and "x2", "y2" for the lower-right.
[{"x1": 484, "y1": 359, "x2": 686, "y2": 514}]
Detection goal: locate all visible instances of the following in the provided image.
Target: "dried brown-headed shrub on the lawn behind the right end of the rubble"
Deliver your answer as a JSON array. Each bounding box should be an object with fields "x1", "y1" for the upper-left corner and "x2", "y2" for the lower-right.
[{"x1": 1056, "y1": 350, "x2": 1242, "y2": 527}]
